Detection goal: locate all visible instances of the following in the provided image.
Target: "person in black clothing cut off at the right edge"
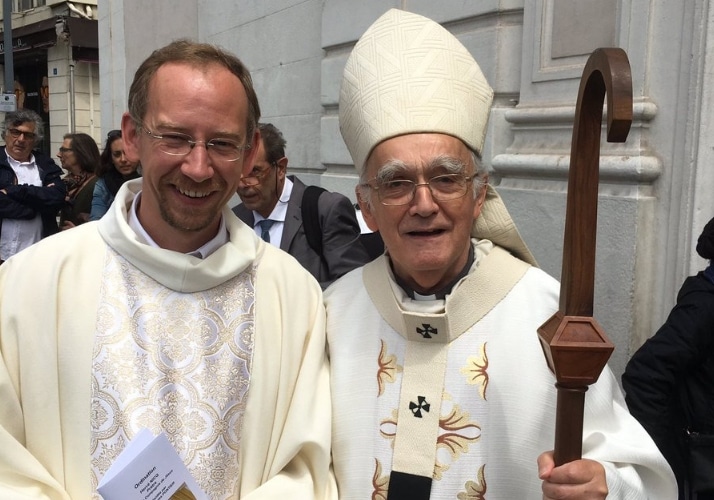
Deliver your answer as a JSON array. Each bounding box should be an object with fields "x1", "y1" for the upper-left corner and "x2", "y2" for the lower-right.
[{"x1": 622, "y1": 218, "x2": 714, "y2": 500}]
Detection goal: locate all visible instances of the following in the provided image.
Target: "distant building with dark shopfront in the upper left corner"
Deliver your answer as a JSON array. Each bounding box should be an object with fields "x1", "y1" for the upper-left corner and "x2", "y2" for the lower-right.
[{"x1": 0, "y1": 0, "x2": 97, "y2": 154}]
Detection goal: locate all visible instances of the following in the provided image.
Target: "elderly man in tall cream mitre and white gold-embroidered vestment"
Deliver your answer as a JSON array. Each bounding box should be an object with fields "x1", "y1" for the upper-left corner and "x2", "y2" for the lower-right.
[{"x1": 325, "y1": 9, "x2": 676, "y2": 500}]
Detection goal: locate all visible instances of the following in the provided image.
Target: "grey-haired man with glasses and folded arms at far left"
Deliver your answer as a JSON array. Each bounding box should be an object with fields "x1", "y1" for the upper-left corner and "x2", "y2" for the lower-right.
[{"x1": 0, "y1": 109, "x2": 67, "y2": 264}]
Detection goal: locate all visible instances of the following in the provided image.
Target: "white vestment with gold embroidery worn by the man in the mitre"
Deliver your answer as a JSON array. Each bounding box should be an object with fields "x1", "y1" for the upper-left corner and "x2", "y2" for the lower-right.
[{"x1": 325, "y1": 240, "x2": 671, "y2": 500}]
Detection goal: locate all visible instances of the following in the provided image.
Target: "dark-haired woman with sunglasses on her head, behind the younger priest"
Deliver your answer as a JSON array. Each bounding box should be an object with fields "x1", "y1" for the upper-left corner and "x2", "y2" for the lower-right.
[{"x1": 89, "y1": 130, "x2": 141, "y2": 220}]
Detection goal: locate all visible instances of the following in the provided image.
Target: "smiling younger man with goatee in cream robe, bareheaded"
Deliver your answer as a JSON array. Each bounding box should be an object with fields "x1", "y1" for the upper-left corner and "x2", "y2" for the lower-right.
[{"x1": 0, "y1": 40, "x2": 334, "y2": 500}]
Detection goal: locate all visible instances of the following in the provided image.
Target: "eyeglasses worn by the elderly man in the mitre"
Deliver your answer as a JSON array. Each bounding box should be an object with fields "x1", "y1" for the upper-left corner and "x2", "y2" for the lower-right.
[{"x1": 367, "y1": 174, "x2": 474, "y2": 206}]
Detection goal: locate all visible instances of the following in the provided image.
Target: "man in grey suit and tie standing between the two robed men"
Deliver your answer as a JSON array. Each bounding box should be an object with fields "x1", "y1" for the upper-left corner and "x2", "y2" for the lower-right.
[{"x1": 233, "y1": 123, "x2": 370, "y2": 290}]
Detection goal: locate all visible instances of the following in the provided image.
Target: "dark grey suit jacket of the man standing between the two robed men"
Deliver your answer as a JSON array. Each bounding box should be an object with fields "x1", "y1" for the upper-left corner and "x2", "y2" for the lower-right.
[{"x1": 233, "y1": 175, "x2": 370, "y2": 290}]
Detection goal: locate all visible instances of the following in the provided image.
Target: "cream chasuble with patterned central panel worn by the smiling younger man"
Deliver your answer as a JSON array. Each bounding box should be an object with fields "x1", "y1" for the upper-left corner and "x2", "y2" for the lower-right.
[{"x1": 0, "y1": 179, "x2": 336, "y2": 500}]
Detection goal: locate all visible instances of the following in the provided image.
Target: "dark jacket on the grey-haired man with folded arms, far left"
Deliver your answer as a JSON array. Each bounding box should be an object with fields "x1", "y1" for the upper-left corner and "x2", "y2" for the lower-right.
[{"x1": 0, "y1": 148, "x2": 67, "y2": 238}]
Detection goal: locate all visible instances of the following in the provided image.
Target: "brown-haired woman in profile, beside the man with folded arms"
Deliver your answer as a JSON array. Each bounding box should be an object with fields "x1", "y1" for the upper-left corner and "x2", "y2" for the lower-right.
[{"x1": 57, "y1": 133, "x2": 99, "y2": 231}]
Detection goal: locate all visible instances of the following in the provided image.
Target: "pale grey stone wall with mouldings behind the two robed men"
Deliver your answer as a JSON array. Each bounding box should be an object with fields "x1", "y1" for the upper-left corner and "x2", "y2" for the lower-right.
[{"x1": 98, "y1": 0, "x2": 714, "y2": 374}]
